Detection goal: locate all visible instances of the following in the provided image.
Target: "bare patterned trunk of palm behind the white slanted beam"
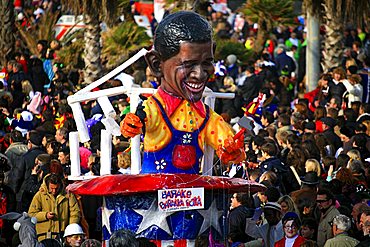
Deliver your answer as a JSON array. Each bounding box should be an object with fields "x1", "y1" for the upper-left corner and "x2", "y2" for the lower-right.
[{"x1": 84, "y1": 11, "x2": 102, "y2": 84}]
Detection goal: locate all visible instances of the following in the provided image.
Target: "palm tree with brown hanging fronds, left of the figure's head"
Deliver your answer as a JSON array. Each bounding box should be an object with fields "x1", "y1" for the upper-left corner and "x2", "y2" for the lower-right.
[{"x1": 62, "y1": 0, "x2": 119, "y2": 84}]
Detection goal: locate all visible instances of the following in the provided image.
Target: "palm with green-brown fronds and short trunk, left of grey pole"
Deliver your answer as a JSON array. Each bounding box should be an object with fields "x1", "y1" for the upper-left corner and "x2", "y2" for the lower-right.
[{"x1": 239, "y1": 0, "x2": 295, "y2": 54}]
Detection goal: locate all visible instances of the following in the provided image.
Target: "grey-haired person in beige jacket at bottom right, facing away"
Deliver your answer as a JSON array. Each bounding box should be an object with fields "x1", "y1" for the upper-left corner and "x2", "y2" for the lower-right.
[{"x1": 324, "y1": 214, "x2": 359, "y2": 247}]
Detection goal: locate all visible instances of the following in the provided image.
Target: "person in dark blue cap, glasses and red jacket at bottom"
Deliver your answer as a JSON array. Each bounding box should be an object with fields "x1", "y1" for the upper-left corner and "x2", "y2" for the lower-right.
[{"x1": 275, "y1": 212, "x2": 306, "y2": 247}]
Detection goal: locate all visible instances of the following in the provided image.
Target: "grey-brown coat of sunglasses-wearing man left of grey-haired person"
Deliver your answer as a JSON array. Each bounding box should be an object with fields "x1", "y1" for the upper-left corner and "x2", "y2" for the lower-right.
[{"x1": 317, "y1": 206, "x2": 340, "y2": 247}]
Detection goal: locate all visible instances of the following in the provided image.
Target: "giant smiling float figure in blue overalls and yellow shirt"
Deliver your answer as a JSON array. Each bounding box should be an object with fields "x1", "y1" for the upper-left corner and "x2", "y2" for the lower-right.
[{"x1": 121, "y1": 11, "x2": 245, "y2": 174}]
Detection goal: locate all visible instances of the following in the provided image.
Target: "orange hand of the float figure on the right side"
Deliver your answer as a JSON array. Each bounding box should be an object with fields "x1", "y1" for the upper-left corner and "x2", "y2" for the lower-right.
[{"x1": 216, "y1": 134, "x2": 246, "y2": 165}]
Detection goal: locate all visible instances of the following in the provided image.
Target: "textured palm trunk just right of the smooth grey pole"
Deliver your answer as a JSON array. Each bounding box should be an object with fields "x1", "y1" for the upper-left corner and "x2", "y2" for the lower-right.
[{"x1": 322, "y1": 0, "x2": 344, "y2": 72}]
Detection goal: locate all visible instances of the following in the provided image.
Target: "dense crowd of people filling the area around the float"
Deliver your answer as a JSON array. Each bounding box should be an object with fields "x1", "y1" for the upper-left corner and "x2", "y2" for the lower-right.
[{"x1": 0, "y1": 1, "x2": 370, "y2": 247}]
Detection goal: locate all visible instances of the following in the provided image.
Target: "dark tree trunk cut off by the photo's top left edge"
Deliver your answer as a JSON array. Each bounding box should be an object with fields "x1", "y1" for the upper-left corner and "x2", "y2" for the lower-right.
[{"x1": 0, "y1": 0, "x2": 15, "y2": 66}]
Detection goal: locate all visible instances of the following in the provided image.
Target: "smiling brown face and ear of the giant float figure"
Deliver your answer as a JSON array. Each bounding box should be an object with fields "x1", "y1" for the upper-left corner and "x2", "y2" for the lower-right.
[{"x1": 160, "y1": 42, "x2": 214, "y2": 102}]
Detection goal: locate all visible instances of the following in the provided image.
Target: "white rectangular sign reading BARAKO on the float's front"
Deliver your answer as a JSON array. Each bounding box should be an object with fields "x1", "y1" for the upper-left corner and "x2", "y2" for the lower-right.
[{"x1": 158, "y1": 188, "x2": 204, "y2": 212}]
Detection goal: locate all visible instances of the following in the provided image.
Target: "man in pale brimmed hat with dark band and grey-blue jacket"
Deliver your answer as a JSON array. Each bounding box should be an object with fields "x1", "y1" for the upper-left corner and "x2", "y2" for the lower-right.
[{"x1": 245, "y1": 202, "x2": 284, "y2": 247}]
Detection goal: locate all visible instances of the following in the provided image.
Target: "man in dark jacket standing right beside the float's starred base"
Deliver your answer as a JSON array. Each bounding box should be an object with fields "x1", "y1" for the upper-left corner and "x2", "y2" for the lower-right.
[{"x1": 228, "y1": 193, "x2": 253, "y2": 246}]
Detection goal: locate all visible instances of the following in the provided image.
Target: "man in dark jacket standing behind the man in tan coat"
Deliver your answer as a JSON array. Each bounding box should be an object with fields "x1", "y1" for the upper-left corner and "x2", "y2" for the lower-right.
[{"x1": 14, "y1": 130, "x2": 45, "y2": 212}]
